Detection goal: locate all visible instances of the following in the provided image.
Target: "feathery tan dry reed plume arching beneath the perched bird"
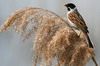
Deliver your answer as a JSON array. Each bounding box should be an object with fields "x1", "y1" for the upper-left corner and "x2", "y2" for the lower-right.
[{"x1": 1, "y1": 7, "x2": 94, "y2": 66}]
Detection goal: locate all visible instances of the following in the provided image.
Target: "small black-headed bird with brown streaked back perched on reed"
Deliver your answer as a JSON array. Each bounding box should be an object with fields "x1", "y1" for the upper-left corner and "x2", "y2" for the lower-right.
[{"x1": 65, "y1": 3, "x2": 98, "y2": 66}]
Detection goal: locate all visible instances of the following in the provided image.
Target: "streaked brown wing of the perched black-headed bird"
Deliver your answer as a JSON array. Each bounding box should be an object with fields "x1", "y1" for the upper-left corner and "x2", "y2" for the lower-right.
[{"x1": 68, "y1": 10, "x2": 89, "y2": 33}]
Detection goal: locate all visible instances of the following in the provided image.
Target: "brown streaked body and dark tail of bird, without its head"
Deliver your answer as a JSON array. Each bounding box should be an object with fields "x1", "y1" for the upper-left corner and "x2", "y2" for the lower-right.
[{"x1": 67, "y1": 10, "x2": 93, "y2": 48}]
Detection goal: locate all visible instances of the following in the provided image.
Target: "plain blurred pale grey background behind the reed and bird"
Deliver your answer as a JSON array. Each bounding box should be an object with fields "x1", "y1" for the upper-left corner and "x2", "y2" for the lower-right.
[{"x1": 0, "y1": 0, "x2": 100, "y2": 66}]
